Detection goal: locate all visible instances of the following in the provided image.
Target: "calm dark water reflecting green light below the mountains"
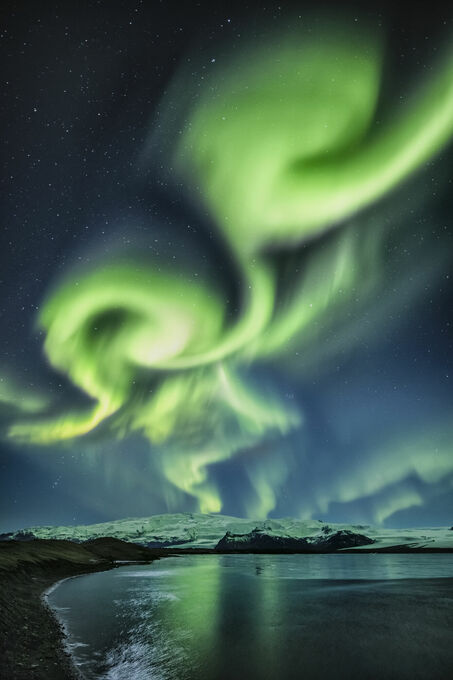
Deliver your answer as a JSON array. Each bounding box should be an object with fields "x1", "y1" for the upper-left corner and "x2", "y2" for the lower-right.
[{"x1": 49, "y1": 554, "x2": 453, "y2": 680}]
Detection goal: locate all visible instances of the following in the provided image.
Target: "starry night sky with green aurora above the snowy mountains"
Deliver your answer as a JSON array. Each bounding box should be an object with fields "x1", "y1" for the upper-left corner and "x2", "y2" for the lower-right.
[{"x1": 0, "y1": 1, "x2": 453, "y2": 531}]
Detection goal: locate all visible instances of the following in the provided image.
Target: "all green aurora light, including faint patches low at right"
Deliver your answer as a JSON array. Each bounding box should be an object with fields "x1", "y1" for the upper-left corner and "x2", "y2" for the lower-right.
[{"x1": 6, "y1": 23, "x2": 453, "y2": 517}]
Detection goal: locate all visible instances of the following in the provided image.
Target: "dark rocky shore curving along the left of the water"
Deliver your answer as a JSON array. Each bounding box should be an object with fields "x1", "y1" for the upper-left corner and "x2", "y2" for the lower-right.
[{"x1": 0, "y1": 538, "x2": 159, "y2": 680}]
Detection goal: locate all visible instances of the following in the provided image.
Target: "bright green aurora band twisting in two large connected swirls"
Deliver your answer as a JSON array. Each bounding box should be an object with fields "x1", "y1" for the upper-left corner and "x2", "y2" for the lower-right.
[{"x1": 5, "y1": 29, "x2": 453, "y2": 512}]
